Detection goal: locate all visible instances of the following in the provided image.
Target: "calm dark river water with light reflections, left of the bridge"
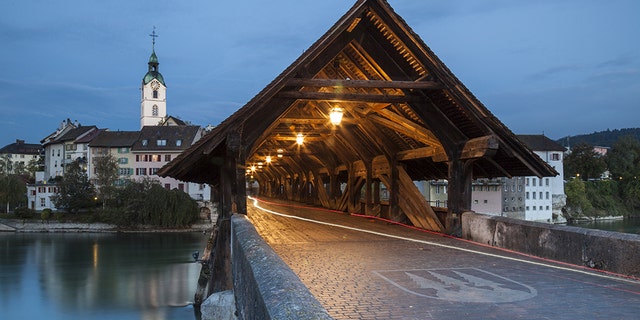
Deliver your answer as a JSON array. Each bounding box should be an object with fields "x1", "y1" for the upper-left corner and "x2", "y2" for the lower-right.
[{"x1": 0, "y1": 232, "x2": 207, "y2": 320}]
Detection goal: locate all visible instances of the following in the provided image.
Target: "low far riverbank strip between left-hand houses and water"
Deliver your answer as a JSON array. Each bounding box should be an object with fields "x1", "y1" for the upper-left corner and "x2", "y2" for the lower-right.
[{"x1": 0, "y1": 219, "x2": 213, "y2": 233}]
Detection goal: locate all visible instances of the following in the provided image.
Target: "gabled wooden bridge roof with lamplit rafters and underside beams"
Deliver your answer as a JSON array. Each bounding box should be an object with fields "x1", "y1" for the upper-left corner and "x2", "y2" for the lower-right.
[{"x1": 159, "y1": 0, "x2": 557, "y2": 183}]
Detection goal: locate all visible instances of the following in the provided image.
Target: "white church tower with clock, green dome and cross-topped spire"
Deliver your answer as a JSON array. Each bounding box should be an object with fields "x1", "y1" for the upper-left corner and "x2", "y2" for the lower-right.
[{"x1": 140, "y1": 28, "x2": 167, "y2": 129}]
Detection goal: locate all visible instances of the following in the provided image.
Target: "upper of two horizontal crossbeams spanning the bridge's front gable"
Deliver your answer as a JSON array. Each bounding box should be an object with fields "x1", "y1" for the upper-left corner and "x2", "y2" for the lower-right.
[{"x1": 287, "y1": 78, "x2": 443, "y2": 90}]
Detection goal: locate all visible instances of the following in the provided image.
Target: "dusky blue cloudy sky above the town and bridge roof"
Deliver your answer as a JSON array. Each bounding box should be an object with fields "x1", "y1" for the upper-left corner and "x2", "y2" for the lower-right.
[{"x1": 0, "y1": 0, "x2": 640, "y2": 146}]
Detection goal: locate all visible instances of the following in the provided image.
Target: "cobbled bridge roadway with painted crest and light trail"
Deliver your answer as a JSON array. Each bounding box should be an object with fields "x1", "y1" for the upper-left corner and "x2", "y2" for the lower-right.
[{"x1": 247, "y1": 198, "x2": 640, "y2": 319}]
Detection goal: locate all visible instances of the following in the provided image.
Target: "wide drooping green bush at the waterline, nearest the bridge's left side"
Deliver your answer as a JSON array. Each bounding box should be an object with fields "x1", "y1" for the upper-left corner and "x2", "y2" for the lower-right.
[{"x1": 102, "y1": 180, "x2": 198, "y2": 228}]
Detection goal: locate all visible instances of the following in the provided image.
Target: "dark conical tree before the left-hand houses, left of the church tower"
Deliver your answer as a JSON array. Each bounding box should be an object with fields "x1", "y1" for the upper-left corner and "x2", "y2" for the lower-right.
[{"x1": 51, "y1": 161, "x2": 95, "y2": 213}]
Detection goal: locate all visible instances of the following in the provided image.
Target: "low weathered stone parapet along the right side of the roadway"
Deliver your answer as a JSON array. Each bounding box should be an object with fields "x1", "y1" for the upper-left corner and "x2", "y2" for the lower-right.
[{"x1": 462, "y1": 212, "x2": 640, "y2": 277}]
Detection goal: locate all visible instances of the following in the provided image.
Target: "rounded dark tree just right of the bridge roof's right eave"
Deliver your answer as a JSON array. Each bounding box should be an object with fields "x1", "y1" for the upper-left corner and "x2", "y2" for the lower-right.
[{"x1": 564, "y1": 143, "x2": 607, "y2": 181}]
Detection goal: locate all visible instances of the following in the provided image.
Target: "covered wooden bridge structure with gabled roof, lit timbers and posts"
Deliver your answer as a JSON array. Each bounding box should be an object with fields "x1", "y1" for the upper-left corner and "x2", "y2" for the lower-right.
[{"x1": 159, "y1": 0, "x2": 557, "y2": 298}]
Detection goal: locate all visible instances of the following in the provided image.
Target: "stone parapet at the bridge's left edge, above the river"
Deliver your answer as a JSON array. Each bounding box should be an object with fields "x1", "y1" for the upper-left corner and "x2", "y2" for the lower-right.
[{"x1": 231, "y1": 215, "x2": 332, "y2": 319}]
